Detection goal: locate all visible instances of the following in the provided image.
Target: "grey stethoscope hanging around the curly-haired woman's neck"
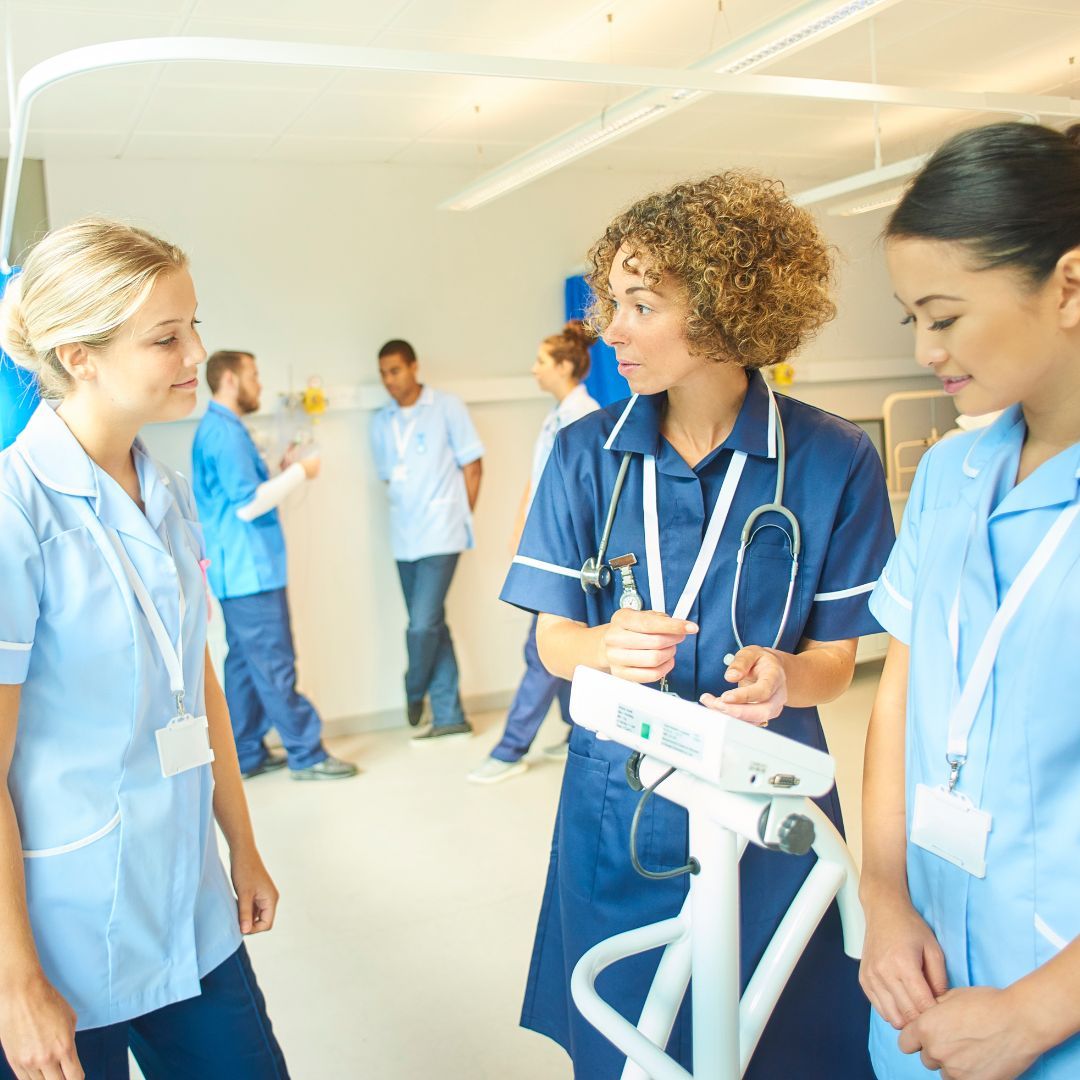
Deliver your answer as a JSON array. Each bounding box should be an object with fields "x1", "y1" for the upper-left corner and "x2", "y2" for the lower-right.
[{"x1": 581, "y1": 393, "x2": 802, "y2": 649}]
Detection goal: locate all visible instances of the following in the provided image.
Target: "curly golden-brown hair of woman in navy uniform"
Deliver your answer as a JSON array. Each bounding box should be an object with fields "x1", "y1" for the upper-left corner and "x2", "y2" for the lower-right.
[{"x1": 586, "y1": 171, "x2": 836, "y2": 367}]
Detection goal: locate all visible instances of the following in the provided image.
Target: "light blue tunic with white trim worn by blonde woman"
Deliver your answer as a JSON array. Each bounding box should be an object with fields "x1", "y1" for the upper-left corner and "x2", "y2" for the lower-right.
[{"x1": 0, "y1": 404, "x2": 241, "y2": 1030}]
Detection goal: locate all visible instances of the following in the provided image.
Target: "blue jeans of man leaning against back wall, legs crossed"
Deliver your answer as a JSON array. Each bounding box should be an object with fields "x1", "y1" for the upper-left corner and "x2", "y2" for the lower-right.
[{"x1": 397, "y1": 554, "x2": 465, "y2": 728}]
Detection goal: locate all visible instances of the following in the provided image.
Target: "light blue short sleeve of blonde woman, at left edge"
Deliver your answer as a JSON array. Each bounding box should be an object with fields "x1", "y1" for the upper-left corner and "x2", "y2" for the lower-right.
[{"x1": 0, "y1": 494, "x2": 44, "y2": 686}]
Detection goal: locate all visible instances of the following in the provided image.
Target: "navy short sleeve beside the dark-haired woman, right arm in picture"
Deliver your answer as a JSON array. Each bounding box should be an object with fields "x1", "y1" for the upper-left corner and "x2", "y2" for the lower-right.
[{"x1": 804, "y1": 434, "x2": 895, "y2": 642}]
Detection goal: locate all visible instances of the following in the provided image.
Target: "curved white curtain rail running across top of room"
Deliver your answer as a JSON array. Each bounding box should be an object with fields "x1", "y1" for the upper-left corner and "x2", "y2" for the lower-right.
[{"x1": 6, "y1": 37, "x2": 1080, "y2": 264}]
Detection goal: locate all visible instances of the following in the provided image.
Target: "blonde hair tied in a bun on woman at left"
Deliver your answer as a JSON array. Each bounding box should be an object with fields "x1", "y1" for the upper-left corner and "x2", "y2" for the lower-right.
[{"x1": 0, "y1": 218, "x2": 188, "y2": 397}]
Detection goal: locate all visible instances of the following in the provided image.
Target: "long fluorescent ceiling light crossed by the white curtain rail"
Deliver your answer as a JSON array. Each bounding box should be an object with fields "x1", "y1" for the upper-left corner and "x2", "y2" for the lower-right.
[{"x1": 440, "y1": 0, "x2": 899, "y2": 211}]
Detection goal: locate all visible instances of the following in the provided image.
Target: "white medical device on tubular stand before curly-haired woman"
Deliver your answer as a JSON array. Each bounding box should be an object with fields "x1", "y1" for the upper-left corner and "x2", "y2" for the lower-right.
[{"x1": 570, "y1": 667, "x2": 865, "y2": 1080}]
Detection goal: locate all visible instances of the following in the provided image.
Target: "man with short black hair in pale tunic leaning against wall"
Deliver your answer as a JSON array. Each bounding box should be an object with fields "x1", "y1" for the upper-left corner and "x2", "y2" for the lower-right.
[{"x1": 372, "y1": 340, "x2": 484, "y2": 742}]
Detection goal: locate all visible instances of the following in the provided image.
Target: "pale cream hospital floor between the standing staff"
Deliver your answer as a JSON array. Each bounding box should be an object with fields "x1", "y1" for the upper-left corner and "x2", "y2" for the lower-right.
[{"x1": 159, "y1": 664, "x2": 880, "y2": 1080}]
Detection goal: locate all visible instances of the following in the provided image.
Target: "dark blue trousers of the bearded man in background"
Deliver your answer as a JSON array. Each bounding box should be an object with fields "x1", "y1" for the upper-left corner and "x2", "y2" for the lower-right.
[{"x1": 221, "y1": 589, "x2": 326, "y2": 772}]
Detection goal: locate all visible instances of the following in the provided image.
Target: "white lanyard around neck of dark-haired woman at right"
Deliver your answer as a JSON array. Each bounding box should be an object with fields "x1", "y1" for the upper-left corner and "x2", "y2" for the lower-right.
[{"x1": 947, "y1": 482, "x2": 1080, "y2": 791}]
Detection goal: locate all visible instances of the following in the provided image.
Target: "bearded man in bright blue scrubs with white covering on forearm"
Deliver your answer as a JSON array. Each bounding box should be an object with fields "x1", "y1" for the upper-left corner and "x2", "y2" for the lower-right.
[{"x1": 192, "y1": 352, "x2": 356, "y2": 780}]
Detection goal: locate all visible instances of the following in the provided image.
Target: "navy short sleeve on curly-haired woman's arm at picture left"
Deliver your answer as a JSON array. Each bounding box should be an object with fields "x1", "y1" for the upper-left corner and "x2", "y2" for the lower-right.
[{"x1": 499, "y1": 438, "x2": 589, "y2": 622}]
